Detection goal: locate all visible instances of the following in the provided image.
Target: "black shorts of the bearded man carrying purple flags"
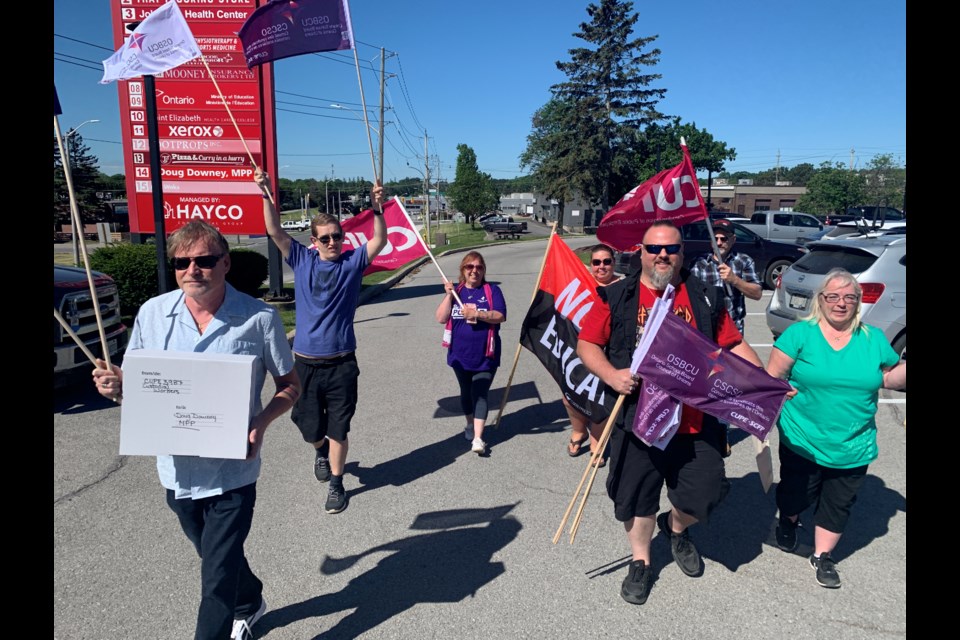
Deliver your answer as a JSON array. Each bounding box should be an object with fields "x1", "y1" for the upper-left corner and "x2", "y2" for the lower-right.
[{"x1": 607, "y1": 416, "x2": 730, "y2": 522}]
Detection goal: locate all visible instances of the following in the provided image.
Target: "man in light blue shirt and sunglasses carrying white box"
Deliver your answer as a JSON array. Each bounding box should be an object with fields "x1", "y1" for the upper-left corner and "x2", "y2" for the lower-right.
[{"x1": 93, "y1": 221, "x2": 300, "y2": 640}]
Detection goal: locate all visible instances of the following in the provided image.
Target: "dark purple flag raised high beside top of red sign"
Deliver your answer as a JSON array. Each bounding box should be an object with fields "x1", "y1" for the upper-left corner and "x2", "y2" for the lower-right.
[{"x1": 237, "y1": 0, "x2": 353, "y2": 69}]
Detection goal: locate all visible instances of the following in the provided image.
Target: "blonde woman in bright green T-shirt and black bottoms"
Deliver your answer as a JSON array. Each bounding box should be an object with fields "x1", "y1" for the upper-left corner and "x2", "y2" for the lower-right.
[{"x1": 767, "y1": 268, "x2": 907, "y2": 589}]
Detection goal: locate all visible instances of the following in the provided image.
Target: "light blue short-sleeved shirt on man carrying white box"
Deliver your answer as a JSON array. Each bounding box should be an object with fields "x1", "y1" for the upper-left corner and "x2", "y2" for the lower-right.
[{"x1": 127, "y1": 283, "x2": 293, "y2": 500}]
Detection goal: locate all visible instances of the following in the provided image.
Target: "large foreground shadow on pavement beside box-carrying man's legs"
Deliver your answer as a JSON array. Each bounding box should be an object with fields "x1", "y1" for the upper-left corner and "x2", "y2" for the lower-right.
[{"x1": 257, "y1": 504, "x2": 522, "y2": 638}]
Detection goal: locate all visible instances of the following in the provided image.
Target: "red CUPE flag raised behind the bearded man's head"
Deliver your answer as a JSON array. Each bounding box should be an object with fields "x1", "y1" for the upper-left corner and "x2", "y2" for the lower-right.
[{"x1": 597, "y1": 144, "x2": 707, "y2": 251}]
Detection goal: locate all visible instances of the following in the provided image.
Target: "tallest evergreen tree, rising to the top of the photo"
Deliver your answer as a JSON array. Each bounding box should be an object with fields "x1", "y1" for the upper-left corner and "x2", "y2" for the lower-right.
[{"x1": 551, "y1": 0, "x2": 666, "y2": 209}]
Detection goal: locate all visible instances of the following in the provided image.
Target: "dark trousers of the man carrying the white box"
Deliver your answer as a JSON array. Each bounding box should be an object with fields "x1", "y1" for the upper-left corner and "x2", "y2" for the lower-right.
[{"x1": 167, "y1": 483, "x2": 263, "y2": 640}]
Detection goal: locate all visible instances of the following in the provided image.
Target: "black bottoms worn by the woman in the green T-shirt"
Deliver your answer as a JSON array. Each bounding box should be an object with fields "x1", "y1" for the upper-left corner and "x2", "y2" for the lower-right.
[{"x1": 777, "y1": 441, "x2": 867, "y2": 533}]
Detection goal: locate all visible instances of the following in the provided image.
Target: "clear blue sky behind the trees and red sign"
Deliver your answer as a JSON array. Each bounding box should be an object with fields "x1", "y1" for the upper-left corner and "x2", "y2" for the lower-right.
[{"x1": 54, "y1": 0, "x2": 907, "y2": 188}]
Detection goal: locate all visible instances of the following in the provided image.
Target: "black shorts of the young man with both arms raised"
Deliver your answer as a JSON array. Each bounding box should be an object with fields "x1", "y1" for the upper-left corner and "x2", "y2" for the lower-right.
[{"x1": 290, "y1": 353, "x2": 360, "y2": 443}]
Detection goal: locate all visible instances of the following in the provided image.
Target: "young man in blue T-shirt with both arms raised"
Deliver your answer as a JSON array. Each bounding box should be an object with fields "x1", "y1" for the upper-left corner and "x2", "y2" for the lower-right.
[{"x1": 254, "y1": 168, "x2": 387, "y2": 513}]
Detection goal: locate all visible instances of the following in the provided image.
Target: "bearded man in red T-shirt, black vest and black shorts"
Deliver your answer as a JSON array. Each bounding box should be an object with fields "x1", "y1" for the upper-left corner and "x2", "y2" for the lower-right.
[{"x1": 577, "y1": 220, "x2": 763, "y2": 604}]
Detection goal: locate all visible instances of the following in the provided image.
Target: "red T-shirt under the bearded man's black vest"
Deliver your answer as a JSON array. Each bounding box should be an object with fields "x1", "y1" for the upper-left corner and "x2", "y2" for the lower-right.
[{"x1": 577, "y1": 282, "x2": 743, "y2": 433}]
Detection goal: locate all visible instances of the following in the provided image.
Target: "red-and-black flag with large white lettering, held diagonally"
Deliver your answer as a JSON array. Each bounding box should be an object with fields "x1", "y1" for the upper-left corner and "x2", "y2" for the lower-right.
[{"x1": 520, "y1": 236, "x2": 615, "y2": 422}]
